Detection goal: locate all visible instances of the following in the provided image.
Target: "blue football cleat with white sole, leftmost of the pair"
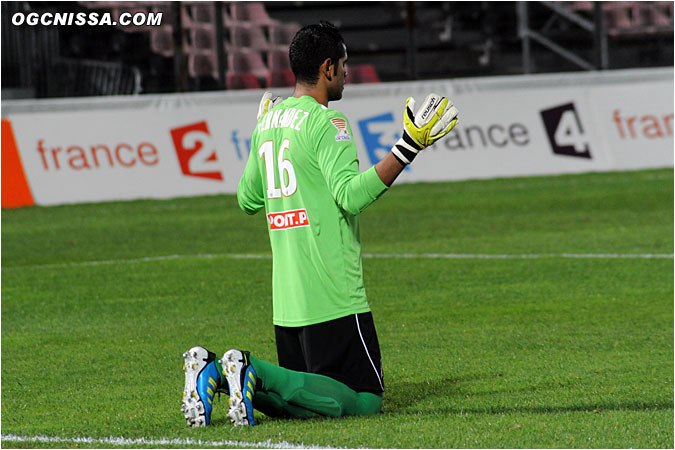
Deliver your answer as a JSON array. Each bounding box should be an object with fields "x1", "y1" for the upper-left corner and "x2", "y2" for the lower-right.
[{"x1": 181, "y1": 347, "x2": 220, "y2": 427}]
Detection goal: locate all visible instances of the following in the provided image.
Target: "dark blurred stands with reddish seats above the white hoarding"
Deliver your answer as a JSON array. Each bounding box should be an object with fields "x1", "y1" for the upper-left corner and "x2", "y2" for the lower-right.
[{"x1": 1, "y1": 1, "x2": 673, "y2": 100}]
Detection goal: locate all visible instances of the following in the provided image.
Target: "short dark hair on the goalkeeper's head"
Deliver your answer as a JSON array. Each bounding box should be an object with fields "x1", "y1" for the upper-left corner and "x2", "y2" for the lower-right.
[{"x1": 288, "y1": 20, "x2": 345, "y2": 84}]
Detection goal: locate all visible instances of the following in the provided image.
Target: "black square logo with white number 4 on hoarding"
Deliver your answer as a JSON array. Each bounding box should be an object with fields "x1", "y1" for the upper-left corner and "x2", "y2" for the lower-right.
[{"x1": 540, "y1": 103, "x2": 591, "y2": 159}]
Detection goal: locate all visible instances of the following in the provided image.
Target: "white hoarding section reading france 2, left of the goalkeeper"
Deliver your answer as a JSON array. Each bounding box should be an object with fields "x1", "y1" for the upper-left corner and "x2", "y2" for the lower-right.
[{"x1": 12, "y1": 106, "x2": 255, "y2": 205}]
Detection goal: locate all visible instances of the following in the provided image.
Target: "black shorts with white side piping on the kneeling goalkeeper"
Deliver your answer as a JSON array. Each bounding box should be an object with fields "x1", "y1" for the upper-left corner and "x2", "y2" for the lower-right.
[{"x1": 274, "y1": 312, "x2": 384, "y2": 394}]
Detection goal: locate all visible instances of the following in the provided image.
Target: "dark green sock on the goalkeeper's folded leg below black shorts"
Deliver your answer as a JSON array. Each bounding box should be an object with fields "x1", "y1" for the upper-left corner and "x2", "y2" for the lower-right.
[{"x1": 251, "y1": 356, "x2": 382, "y2": 417}]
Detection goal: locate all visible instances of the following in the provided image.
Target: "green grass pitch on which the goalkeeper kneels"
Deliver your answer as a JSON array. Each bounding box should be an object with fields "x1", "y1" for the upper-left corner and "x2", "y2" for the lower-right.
[{"x1": 2, "y1": 170, "x2": 673, "y2": 448}]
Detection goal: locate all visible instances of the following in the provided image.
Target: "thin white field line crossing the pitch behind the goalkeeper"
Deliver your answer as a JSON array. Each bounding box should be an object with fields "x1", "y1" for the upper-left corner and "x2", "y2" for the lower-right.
[{"x1": 3, "y1": 253, "x2": 673, "y2": 269}]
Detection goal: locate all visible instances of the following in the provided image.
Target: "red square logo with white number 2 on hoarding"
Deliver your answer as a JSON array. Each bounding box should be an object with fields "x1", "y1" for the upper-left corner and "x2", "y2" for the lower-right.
[{"x1": 171, "y1": 120, "x2": 223, "y2": 181}]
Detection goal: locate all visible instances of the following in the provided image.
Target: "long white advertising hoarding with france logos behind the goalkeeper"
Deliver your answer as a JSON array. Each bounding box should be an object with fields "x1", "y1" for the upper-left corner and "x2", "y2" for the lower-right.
[{"x1": 3, "y1": 70, "x2": 673, "y2": 205}]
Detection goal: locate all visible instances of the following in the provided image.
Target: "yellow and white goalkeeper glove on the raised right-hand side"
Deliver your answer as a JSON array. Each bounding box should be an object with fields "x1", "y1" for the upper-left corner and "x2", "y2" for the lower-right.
[{"x1": 391, "y1": 94, "x2": 459, "y2": 166}]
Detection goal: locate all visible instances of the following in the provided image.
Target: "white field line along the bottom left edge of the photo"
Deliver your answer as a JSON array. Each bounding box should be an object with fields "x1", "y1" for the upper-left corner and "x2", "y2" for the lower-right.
[{"x1": 0, "y1": 434, "x2": 340, "y2": 449}]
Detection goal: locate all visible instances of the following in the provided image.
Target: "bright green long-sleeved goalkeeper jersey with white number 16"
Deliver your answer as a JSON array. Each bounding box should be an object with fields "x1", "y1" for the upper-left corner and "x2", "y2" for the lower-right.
[{"x1": 237, "y1": 96, "x2": 387, "y2": 327}]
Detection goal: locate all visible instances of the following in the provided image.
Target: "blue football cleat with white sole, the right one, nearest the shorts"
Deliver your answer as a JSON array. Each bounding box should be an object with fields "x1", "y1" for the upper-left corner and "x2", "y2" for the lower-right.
[{"x1": 220, "y1": 349, "x2": 258, "y2": 426}]
